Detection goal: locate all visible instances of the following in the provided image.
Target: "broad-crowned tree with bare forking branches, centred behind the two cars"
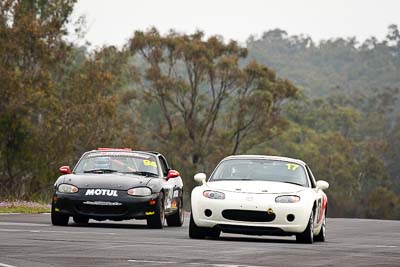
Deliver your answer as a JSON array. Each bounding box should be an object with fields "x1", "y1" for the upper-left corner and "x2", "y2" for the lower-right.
[{"x1": 129, "y1": 28, "x2": 297, "y2": 194}]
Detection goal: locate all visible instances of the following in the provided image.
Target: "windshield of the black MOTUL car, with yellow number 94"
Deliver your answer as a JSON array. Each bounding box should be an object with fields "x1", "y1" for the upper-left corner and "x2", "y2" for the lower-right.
[{"x1": 75, "y1": 152, "x2": 158, "y2": 176}]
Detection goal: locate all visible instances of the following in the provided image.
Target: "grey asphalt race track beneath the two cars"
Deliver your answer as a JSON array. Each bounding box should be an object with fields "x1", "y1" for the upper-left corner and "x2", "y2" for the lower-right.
[{"x1": 0, "y1": 214, "x2": 400, "y2": 267}]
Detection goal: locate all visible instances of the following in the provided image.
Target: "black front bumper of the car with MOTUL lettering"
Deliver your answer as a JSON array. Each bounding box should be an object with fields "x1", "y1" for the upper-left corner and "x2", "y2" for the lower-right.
[{"x1": 52, "y1": 191, "x2": 158, "y2": 221}]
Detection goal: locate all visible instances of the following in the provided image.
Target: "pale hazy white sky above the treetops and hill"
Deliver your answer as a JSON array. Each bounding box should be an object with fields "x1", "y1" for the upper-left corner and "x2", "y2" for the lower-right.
[{"x1": 73, "y1": 0, "x2": 400, "y2": 47}]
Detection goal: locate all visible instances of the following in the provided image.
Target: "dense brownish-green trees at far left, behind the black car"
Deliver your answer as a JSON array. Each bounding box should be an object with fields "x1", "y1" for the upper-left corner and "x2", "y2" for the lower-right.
[{"x1": 0, "y1": 0, "x2": 135, "y2": 198}]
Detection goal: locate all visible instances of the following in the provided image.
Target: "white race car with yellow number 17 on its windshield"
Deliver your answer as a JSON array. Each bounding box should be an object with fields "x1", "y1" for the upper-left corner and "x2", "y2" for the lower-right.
[{"x1": 189, "y1": 155, "x2": 329, "y2": 243}]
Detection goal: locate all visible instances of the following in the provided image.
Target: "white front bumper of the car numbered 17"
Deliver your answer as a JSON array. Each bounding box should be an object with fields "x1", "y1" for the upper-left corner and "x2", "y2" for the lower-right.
[{"x1": 192, "y1": 192, "x2": 312, "y2": 235}]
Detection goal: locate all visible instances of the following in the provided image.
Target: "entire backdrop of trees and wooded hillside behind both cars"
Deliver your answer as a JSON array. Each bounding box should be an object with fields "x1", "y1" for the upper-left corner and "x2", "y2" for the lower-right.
[{"x1": 0, "y1": 0, "x2": 400, "y2": 219}]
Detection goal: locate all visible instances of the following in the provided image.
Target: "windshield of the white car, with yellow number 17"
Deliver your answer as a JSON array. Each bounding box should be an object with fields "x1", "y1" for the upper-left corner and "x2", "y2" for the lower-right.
[{"x1": 209, "y1": 159, "x2": 308, "y2": 187}]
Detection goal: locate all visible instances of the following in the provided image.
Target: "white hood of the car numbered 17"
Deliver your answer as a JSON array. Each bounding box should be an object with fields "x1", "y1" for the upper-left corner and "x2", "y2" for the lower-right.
[{"x1": 206, "y1": 180, "x2": 305, "y2": 194}]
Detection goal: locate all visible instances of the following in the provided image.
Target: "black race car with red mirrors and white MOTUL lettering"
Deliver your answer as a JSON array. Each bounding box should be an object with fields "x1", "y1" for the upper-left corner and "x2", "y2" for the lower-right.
[{"x1": 51, "y1": 148, "x2": 183, "y2": 228}]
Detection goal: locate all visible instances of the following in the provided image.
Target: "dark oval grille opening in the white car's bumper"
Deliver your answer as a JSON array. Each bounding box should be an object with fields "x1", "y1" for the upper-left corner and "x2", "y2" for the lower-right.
[{"x1": 222, "y1": 210, "x2": 276, "y2": 222}]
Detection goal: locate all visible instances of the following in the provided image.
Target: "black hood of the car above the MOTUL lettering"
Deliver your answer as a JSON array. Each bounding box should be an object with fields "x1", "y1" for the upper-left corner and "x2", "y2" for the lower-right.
[{"x1": 61, "y1": 173, "x2": 153, "y2": 190}]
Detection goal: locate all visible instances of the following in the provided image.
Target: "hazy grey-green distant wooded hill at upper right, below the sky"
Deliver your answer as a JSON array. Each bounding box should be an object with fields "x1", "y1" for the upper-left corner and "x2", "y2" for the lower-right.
[{"x1": 247, "y1": 25, "x2": 400, "y2": 96}]
